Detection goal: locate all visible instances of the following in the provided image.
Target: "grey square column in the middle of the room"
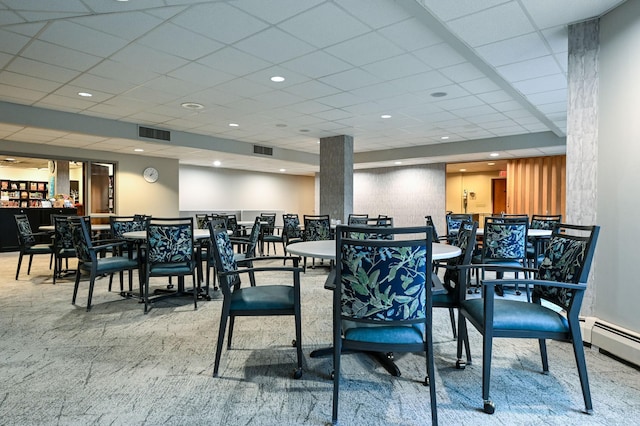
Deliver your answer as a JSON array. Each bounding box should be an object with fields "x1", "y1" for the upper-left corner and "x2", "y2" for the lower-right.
[{"x1": 318, "y1": 135, "x2": 353, "y2": 223}]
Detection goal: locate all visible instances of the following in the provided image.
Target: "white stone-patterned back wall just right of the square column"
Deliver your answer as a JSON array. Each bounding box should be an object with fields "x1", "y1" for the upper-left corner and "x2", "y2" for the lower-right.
[{"x1": 353, "y1": 164, "x2": 446, "y2": 235}]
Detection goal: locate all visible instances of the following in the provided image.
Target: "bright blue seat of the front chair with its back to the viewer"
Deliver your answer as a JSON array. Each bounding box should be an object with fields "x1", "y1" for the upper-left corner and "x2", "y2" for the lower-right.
[{"x1": 342, "y1": 321, "x2": 424, "y2": 345}]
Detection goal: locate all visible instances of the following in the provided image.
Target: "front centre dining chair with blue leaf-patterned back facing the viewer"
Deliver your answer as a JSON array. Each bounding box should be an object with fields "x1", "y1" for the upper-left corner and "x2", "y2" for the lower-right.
[{"x1": 332, "y1": 226, "x2": 438, "y2": 424}]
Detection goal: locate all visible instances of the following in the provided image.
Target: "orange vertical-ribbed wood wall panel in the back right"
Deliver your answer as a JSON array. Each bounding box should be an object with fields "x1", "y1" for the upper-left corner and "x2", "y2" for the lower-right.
[{"x1": 507, "y1": 155, "x2": 567, "y2": 217}]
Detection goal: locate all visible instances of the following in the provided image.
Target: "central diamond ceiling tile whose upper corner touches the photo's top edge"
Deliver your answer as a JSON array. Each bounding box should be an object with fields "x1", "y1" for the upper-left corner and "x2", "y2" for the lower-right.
[{"x1": 279, "y1": 2, "x2": 370, "y2": 48}]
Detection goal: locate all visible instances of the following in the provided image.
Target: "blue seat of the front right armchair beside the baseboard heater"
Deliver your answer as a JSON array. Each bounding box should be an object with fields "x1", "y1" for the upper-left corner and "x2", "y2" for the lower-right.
[{"x1": 462, "y1": 299, "x2": 569, "y2": 333}]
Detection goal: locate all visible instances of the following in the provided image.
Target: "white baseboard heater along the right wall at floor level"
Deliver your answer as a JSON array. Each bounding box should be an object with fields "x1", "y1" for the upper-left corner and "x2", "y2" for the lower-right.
[{"x1": 580, "y1": 317, "x2": 640, "y2": 366}]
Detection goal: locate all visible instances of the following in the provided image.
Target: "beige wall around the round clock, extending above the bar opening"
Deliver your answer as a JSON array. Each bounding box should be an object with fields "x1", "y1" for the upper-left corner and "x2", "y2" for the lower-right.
[{"x1": 0, "y1": 141, "x2": 179, "y2": 217}]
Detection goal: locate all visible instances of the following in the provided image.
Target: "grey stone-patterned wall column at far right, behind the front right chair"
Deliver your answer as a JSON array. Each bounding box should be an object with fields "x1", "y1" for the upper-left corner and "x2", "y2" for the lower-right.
[{"x1": 566, "y1": 19, "x2": 600, "y2": 316}]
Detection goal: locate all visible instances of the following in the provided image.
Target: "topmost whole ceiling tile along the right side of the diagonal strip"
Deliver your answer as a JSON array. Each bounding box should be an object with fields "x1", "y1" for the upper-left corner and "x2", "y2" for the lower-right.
[{"x1": 447, "y1": 2, "x2": 535, "y2": 47}]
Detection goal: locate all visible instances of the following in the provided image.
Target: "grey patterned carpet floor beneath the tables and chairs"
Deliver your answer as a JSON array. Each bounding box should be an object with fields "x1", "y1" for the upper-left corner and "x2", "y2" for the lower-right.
[{"x1": 0, "y1": 253, "x2": 640, "y2": 426}]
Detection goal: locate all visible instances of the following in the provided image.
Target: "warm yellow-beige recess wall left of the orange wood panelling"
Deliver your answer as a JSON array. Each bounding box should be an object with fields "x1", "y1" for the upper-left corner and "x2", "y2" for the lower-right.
[{"x1": 446, "y1": 172, "x2": 500, "y2": 216}]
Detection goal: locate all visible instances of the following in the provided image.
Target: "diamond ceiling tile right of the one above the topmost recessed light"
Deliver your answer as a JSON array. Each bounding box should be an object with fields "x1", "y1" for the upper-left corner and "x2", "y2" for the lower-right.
[{"x1": 326, "y1": 32, "x2": 403, "y2": 66}]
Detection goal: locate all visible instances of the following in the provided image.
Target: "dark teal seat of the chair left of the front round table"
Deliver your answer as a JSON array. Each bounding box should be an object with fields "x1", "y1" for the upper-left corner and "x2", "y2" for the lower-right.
[{"x1": 231, "y1": 285, "x2": 295, "y2": 312}]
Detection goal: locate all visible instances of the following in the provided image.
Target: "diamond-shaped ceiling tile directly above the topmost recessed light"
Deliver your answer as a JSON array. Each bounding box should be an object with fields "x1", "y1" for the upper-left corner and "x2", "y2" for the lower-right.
[{"x1": 235, "y1": 28, "x2": 315, "y2": 63}]
